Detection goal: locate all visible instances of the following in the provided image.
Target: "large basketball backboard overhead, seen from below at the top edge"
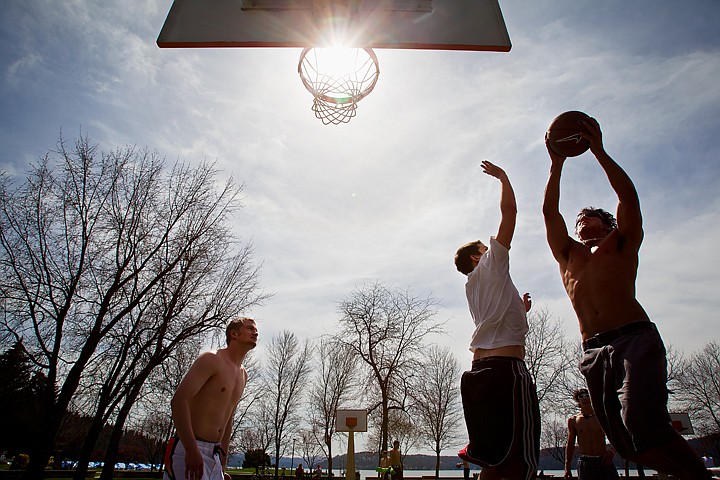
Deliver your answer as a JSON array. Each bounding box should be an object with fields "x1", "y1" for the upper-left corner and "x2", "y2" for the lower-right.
[{"x1": 157, "y1": 0, "x2": 511, "y2": 52}]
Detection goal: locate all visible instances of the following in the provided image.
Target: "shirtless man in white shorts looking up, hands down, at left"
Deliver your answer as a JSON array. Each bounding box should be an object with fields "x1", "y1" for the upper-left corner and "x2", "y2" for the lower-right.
[{"x1": 165, "y1": 318, "x2": 258, "y2": 480}]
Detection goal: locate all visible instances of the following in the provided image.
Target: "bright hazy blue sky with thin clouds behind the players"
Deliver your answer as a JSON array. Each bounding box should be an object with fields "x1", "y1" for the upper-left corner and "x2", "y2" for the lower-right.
[{"x1": 0, "y1": 0, "x2": 720, "y2": 456}]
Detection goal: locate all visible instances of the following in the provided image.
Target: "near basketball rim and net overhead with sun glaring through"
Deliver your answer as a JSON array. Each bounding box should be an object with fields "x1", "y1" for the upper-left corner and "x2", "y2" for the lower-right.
[{"x1": 298, "y1": 47, "x2": 380, "y2": 125}]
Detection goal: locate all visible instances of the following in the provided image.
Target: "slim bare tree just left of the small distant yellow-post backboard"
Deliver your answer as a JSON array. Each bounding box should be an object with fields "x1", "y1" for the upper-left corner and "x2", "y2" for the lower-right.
[{"x1": 308, "y1": 338, "x2": 358, "y2": 471}]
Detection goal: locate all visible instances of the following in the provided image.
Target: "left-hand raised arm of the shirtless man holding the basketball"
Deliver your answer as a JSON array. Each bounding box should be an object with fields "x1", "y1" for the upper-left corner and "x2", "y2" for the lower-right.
[{"x1": 543, "y1": 135, "x2": 571, "y2": 268}]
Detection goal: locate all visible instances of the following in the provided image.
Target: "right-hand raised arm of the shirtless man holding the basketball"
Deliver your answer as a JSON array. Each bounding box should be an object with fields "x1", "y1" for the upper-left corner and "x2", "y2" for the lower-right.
[{"x1": 582, "y1": 118, "x2": 643, "y2": 247}]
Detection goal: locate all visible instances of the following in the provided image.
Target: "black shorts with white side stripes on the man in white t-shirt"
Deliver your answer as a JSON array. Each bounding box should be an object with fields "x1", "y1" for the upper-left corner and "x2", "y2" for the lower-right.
[{"x1": 460, "y1": 357, "x2": 540, "y2": 475}]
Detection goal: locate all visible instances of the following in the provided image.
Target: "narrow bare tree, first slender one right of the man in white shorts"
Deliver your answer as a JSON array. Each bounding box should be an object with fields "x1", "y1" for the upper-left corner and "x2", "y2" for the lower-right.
[{"x1": 264, "y1": 330, "x2": 312, "y2": 477}]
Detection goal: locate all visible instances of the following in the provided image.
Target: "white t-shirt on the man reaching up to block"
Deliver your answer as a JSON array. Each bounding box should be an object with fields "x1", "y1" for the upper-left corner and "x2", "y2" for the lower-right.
[{"x1": 465, "y1": 237, "x2": 528, "y2": 352}]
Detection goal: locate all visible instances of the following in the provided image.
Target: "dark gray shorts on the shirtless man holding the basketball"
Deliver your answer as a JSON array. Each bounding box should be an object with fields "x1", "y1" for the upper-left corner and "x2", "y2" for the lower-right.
[{"x1": 580, "y1": 322, "x2": 678, "y2": 458}]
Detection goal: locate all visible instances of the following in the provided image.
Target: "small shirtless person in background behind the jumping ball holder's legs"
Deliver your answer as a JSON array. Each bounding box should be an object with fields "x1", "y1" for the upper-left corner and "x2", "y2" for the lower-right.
[{"x1": 565, "y1": 388, "x2": 619, "y2": 480}]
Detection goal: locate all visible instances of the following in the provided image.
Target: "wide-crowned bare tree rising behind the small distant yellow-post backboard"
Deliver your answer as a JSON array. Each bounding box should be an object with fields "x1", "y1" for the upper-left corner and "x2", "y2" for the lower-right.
[{"x1": 336, "y1": 283, "x2": 442, "y2": 460}]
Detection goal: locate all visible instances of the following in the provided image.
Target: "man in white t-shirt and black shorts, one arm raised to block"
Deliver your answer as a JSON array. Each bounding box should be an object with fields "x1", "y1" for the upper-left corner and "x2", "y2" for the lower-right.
[{"x1": 455, "y1": 160, "x2": 540, "y2": 480}]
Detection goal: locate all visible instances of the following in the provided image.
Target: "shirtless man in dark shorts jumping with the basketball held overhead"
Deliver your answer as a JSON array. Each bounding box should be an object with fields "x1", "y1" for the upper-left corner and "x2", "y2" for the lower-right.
[{"x1": 543, "y1": 118, "x2": 711, "y2": 480}]
